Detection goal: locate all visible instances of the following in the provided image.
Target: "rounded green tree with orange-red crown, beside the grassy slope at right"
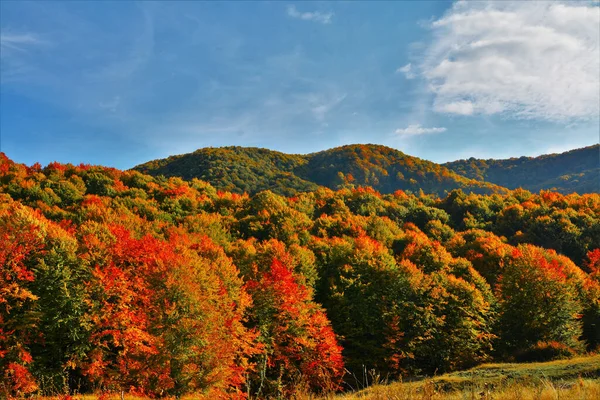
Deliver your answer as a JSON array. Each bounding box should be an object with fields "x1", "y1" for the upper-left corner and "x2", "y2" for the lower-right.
[{"x1": 497, "y1": 245, "x2": 583, "y2": 355}]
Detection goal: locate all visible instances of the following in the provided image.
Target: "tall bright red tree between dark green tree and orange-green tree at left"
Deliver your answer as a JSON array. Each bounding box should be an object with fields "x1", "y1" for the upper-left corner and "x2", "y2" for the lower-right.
[{"x1": 84, "y1": 226, "x2": 174, "y2": 392}]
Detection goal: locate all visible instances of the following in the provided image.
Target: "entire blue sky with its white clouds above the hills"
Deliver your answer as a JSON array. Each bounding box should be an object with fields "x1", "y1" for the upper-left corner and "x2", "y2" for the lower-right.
[{"x1": 0, "y1": 1, "x2": 600, "y2": 168}]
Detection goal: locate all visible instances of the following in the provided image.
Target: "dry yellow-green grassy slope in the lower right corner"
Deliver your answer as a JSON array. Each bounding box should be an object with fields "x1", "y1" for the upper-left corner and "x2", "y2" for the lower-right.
[{"x1": 336, "y1": 355, "x2": 600, "y2": 400}]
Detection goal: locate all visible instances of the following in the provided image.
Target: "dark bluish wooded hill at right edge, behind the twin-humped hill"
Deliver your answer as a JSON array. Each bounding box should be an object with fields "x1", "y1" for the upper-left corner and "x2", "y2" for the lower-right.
[{"x1": 443, "y1": 145, "x2": 600, "y2": 194}]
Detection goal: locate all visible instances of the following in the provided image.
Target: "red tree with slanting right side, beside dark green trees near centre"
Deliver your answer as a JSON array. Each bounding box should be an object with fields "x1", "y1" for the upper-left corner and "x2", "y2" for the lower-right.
[{"x1": 246, "y1": 259, "x2": 343, "y2": 395}]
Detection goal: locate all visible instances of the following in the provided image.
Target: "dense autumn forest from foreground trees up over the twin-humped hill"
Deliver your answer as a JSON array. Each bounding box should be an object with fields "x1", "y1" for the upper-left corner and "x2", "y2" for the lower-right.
[{"x1": 0, "y1": 152, "x2": 600, "y2": 399}]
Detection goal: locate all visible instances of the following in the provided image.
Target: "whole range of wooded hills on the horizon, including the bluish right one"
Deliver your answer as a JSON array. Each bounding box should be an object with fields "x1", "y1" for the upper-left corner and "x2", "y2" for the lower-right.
[{"x1": 132, "y1": 144, "x2": 600, "y2": 196}]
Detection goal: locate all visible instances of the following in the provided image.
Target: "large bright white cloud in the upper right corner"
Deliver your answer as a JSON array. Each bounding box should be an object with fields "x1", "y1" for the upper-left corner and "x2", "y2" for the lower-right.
[{"x1": 420, "y1": 1, "x2": 600, "y2": 121}]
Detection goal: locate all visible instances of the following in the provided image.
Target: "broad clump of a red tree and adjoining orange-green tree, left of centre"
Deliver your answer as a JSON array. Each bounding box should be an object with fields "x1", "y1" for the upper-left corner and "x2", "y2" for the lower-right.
[{"x1": 82, "y1": 225, "x2": 254, "y2": 396}]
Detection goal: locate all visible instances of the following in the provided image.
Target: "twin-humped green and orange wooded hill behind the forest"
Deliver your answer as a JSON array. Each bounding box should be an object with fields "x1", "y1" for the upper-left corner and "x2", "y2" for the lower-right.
[{"x1": 134, "y1": 145, "x2": 506, "y2": 195}]
